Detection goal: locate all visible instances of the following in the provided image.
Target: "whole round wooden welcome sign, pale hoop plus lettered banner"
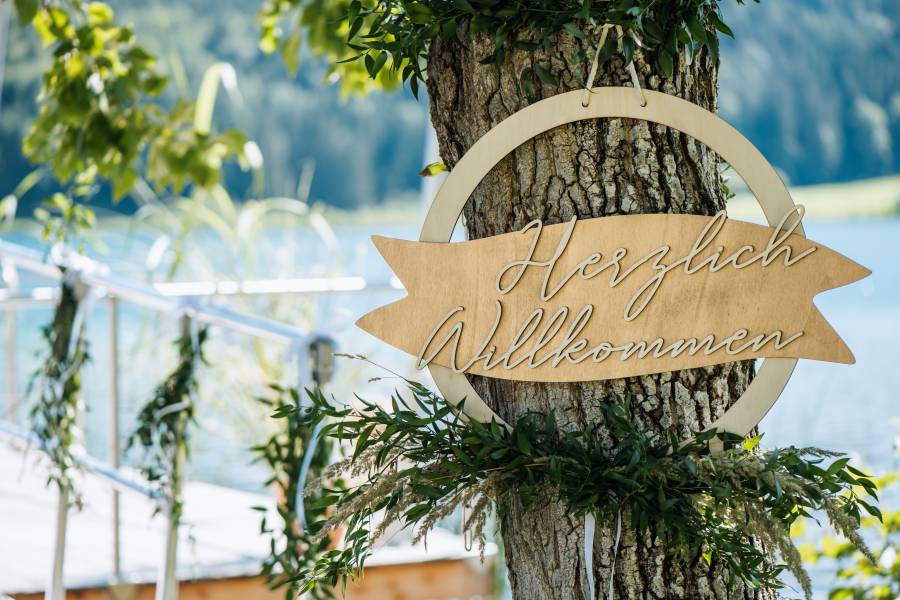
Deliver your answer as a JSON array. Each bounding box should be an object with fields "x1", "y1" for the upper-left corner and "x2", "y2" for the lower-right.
[{"x1": 357, "y1": 87, "x2": 869, "y2": 435}]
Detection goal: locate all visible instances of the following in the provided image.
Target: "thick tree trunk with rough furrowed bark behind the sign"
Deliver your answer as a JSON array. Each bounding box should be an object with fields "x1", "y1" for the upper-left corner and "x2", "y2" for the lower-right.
[{"x1": 428, "y1": 27, "x2": 767, "y2": 600}]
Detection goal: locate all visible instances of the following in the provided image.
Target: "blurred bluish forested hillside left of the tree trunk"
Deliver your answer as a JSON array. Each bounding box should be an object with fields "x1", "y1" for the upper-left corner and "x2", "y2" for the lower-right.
[{"x1": 0, "y1": 0, "x2": 426, "y2": 216}]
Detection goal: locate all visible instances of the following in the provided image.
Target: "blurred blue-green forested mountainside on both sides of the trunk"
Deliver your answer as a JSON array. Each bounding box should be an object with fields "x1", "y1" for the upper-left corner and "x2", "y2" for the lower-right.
[{"x1": 0, "y1": 0, "x2": 900, "y2": 214}]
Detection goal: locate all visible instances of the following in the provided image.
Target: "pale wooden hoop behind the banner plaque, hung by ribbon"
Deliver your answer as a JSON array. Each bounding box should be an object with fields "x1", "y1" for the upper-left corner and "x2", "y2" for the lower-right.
[{"x1": 410, "y1": 84, "x2": 824, "y2": 435}]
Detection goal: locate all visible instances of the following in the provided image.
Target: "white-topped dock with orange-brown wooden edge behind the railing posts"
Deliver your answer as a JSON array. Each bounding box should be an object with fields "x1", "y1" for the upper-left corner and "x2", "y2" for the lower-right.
[{"x1": 0, "y1": 441, "x2": 495, "y2": 600}]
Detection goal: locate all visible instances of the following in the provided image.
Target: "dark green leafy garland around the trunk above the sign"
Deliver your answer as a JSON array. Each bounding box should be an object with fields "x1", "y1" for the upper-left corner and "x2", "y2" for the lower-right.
[{"x1": 314, "y1": 0, "x2": 759, "y2": 95}]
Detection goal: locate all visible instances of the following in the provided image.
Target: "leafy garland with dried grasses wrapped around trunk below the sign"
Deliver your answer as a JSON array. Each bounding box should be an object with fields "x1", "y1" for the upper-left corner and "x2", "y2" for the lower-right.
[{"x1": 285, "y1": 382, "x2": 880, "y2": 598}]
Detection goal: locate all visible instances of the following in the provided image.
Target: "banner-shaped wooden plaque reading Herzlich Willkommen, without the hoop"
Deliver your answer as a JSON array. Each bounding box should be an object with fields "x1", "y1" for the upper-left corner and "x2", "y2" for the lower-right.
[{"x1": 357, "y1": 207, "x2": 869, "y2": 382}]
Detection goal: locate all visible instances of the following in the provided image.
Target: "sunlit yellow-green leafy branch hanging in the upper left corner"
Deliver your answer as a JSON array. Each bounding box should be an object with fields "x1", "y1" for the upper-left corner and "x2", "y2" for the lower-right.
[{"x1": 15, "y1": 0, "x2": 250, "y2": 204}]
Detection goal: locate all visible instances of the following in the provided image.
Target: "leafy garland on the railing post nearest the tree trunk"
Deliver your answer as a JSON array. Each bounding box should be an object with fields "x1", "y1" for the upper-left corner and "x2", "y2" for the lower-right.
[{"x1": 251, "y1": 385, "x2": 344, "y2": 600}]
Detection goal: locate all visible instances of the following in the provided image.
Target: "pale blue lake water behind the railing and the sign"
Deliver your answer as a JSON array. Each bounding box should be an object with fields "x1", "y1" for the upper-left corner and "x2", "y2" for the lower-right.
[{"x1": 0, "y1": 218, "x2": 900, "y2": 589}]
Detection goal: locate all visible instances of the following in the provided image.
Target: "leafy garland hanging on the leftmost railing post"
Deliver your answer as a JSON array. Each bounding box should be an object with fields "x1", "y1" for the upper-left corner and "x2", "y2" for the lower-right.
[{"x1": 29, "y1": 279, "x2": 89, "y2": 503}]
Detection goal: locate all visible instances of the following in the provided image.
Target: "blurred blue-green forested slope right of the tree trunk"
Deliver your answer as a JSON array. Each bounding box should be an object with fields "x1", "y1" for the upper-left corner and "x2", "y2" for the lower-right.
[{"x1": 719, "y1": 0, "x2": 900, "y2": 185}]
